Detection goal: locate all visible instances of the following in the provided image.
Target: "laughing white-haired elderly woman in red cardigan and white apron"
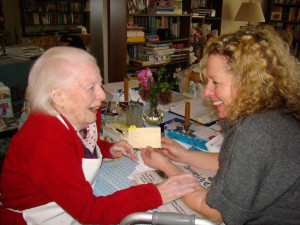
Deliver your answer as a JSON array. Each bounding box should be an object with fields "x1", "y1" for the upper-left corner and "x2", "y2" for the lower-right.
[{"x1": 0, "y1": 47, "x2": 199, "y2": 225}]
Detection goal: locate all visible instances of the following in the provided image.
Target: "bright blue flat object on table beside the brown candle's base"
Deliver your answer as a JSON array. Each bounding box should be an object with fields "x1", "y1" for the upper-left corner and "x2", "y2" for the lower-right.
[{"x1": 167, "y1": 130, "x2": 208, "y2": 151}]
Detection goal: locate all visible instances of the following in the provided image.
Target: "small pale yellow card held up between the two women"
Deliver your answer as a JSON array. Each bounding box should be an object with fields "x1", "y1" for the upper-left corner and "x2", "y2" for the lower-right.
[{"x1": 128, "y1": 127, "x2": 161, "y2": 148}]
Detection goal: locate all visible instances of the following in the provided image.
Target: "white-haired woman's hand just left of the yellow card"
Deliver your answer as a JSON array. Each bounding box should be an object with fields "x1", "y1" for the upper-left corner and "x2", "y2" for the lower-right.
[{"x1": 110, "y1": 140, "x2": 138, "y2": 161}]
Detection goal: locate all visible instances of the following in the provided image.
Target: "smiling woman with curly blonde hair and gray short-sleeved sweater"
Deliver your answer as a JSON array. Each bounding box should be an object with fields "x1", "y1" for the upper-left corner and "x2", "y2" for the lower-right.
[{"x1": 143, "y1": 30, "x2": 300, "y2": 225}]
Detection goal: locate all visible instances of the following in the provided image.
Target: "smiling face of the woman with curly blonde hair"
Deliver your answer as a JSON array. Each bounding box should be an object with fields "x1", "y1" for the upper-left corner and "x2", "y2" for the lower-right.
[{"x1": 203, "y1": 55, "x2": 235, "y2": 118}]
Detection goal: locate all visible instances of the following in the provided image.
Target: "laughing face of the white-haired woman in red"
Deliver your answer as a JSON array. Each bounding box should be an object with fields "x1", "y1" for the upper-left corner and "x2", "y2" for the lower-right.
[{"x1": 59, "y1": 62, "x2": 106, "y2": 130}]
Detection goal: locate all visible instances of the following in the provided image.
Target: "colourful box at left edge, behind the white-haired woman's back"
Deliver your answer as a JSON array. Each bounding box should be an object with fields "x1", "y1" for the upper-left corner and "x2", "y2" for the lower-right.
[{"x1": 0, "y1": 82, "x2": 14, "y2": 118}]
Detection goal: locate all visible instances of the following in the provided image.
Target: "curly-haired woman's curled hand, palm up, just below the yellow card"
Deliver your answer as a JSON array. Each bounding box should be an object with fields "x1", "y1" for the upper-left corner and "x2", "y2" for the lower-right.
[{"x1": 140, "y1": 146, "x2": 171, "y2": 171}]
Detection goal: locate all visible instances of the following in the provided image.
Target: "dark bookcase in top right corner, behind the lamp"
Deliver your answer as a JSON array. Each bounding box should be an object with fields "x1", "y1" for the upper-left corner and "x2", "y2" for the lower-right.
[{"x1": 266, "y1": 0, "x2": 300, "y2": 58}]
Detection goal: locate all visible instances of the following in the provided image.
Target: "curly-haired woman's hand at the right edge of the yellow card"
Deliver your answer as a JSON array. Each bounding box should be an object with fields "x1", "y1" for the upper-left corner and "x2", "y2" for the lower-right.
[{"x1": 160, "y1": 138, "x2": 189, "y2": 163}]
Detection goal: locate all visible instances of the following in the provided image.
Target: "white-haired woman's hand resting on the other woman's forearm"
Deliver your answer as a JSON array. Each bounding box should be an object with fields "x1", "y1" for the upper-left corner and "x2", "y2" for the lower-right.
[{"x1": 157, "y1": 173, "x2": 201, "y2": 204}]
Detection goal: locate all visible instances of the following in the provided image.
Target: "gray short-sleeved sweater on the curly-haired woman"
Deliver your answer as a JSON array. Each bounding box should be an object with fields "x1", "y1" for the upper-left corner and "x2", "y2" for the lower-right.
[{"x1": 206, "y1": 110, "x2": 300, "y2": 225}]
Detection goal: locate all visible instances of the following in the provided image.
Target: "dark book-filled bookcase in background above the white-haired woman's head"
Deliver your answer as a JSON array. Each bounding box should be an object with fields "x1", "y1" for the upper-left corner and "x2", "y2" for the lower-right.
[{"x1": 20, "y1": 0, "x2": 89, "y2": 36}]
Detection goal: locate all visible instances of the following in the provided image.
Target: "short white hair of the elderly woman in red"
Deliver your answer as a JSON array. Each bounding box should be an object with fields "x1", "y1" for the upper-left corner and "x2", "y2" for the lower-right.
[{"x1": 27, "y1": 47, "x2": 96, "y2": 115}]
